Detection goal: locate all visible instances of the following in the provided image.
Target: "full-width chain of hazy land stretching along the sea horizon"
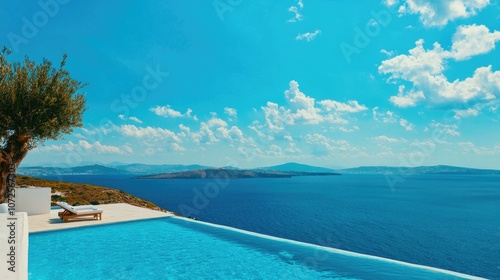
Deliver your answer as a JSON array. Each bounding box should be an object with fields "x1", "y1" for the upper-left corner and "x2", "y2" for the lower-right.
[{"x1": 17, "y1": 162, "x2": 500, "y2": 178}]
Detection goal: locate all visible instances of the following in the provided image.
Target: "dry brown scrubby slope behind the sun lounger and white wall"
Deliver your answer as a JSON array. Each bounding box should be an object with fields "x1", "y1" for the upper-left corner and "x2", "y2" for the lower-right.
[{"x1": 17, "y1": 176, "x2": 166, "y2": 211}]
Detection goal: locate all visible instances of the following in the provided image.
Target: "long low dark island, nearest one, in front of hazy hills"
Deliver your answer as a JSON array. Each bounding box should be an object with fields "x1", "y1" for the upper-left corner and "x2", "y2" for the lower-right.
[{"x1": 135, "y1": 168, "x2": 341, "y2": 179}]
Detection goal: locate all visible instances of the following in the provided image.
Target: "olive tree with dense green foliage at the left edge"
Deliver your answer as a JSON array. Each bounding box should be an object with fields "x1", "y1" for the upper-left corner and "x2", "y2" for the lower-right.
[{"x1": 0, "y1": 48, "x2": 86, "y2": 203}]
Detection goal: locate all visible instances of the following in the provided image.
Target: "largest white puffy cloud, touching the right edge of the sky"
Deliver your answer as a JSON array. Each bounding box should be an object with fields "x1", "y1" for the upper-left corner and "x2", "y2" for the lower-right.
[{"x1": 378, "y1": 25, "x2": 500, "y2": 114}]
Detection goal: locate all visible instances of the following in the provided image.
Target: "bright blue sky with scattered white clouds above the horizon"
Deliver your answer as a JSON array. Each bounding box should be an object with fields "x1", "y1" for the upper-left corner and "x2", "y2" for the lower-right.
[{"x1": 0, "y1": 0, "x2": 500, "y2": 169}]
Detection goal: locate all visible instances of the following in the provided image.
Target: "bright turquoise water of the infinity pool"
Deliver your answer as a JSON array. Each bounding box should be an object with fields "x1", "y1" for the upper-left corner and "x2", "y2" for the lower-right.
[{"x1": 28, "y1": 217, "x2": 482, "y2": 280}]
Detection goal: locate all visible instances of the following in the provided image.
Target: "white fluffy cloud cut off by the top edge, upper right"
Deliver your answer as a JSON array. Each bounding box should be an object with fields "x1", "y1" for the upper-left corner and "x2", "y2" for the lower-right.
[{"x1": 396, "y1": 0, "x2": 490, "y2": 27}]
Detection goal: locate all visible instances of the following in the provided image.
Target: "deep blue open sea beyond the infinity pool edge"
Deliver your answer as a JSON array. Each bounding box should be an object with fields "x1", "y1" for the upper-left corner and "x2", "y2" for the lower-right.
[{"x1": 44, "y1": 175, "x2": 500, "y2": 279}]
